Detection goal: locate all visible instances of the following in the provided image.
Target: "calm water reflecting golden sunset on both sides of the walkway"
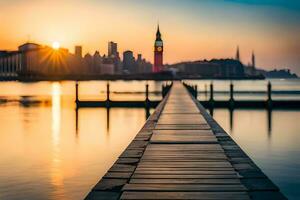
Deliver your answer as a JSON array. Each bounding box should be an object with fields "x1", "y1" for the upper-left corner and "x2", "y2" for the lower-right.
[{"x1": 0, "y1": 80, "x2": 300, "y2": 199}]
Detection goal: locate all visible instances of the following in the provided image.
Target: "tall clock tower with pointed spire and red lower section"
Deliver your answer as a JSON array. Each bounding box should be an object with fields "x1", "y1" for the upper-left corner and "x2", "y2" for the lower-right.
[{"x1": 152, "y1": 25, "x2": 164, "y2": 72}]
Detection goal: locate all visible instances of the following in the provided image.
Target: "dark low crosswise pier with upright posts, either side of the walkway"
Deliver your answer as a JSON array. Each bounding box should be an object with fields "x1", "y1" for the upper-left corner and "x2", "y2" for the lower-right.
[{"x1": 75, "y1": 82, "x2": 300, "y2": 110}]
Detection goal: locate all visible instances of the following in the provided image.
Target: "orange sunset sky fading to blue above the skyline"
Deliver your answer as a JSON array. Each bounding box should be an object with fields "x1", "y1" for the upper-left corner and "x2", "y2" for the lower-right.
[{"x1": 0, "y1": 0, "x2": 300, "y2": 74}]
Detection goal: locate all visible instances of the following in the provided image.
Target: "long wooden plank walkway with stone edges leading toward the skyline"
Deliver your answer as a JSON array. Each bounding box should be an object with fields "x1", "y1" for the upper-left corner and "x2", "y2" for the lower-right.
[{"x1": 86, "y1": 82, "x2": 286, "y2": 200}]
